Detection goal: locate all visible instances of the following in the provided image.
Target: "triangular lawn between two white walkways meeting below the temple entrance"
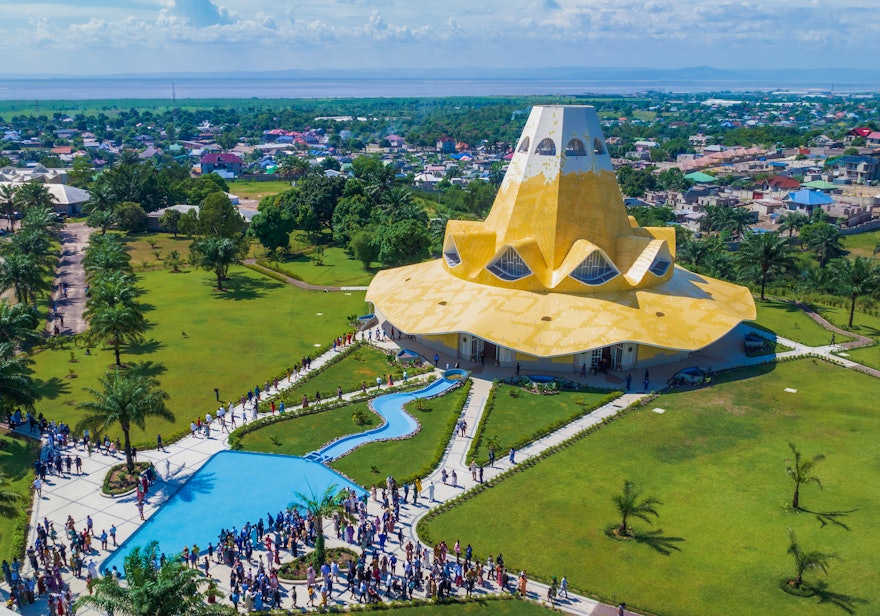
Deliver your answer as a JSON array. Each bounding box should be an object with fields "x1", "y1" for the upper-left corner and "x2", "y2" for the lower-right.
[{"x1": 468, "y1": 384, "x2": 620, "y2": 464}]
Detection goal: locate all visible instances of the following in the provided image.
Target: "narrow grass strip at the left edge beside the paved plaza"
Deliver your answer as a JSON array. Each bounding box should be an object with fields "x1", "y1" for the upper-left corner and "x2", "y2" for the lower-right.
[{"x1": 0, "y1": 433, "x2": 40, "y2": 562}]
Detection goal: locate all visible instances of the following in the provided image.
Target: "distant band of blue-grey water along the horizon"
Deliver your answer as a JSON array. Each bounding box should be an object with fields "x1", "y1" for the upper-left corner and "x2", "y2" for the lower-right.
[{"x1": 0, "y1": 74, "x2": 878, "y2": 101}]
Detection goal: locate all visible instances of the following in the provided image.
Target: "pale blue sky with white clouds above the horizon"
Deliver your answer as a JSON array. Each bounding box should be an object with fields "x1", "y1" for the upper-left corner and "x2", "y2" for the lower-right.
[{"x1": 0, "y1": 0, "x2": 880, "y2": 75}]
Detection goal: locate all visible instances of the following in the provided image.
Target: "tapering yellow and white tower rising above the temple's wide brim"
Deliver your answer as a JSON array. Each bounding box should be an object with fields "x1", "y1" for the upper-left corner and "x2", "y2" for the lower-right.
[{"x1": 444, "y1": 106, "x2": 675, "y2": 293}]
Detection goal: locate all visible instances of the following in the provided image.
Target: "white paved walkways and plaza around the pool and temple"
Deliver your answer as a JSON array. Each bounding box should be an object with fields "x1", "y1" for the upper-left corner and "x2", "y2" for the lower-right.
[{"x1": 8, "y1": 308, "x2": 880, "y2": 616}]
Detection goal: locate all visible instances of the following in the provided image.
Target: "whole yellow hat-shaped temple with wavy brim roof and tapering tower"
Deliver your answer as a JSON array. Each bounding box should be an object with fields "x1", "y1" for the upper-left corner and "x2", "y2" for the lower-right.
[{"x1": 367, "y1": 105, "x2": 755, "y2": 372}]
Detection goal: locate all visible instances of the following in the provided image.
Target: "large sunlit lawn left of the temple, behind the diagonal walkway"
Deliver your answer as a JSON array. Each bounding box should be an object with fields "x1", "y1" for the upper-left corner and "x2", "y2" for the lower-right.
[{"x1": 27, "y1": 268, "x2": 366, "y2": 447}]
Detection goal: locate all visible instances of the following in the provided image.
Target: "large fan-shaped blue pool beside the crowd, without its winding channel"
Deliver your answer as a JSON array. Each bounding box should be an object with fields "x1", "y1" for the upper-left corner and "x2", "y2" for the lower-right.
[{"x1": 101, "y1": 451, "x2": 365, "y2": 571}]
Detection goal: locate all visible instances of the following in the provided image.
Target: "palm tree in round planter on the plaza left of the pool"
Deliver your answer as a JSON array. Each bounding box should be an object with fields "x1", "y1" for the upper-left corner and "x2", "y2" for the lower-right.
[{"x1": 76, "y1": 369, "x2": 174, "y2": 472}]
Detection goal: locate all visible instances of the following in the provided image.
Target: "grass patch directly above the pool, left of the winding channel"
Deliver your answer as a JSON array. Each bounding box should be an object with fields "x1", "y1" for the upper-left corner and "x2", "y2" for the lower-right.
[{"x1": 235, "y1": 402, "x2": 382, "y2": 456}]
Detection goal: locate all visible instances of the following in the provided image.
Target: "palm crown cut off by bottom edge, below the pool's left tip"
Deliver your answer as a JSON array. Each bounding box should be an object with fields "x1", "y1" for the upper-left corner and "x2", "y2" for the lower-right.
[{"x1": 75, "y1": 541, "x2": 235, "y2": 616}]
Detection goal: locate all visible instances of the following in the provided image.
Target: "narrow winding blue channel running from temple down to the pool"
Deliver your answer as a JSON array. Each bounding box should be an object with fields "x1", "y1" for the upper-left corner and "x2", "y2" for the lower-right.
[{"x1": 306, "y1": 370, "x2": 467, "y2": 462}]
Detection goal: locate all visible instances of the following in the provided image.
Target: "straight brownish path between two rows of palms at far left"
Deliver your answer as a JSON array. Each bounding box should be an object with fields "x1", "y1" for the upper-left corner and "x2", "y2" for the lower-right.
[{"x1": 46, "y1": 222, "x2": 92, "y2": 335}]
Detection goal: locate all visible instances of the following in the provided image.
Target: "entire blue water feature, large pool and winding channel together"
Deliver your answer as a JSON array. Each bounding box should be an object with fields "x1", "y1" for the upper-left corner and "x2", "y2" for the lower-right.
[{"x1": 101, "y1": 370, "x2": 467, "y2": 572}]
